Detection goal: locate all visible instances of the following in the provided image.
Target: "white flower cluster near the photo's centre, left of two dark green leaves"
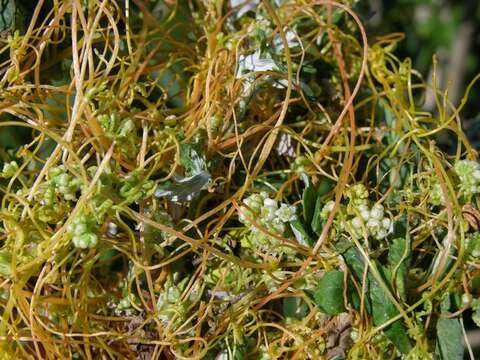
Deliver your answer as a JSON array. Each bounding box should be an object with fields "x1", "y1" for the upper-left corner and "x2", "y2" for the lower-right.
[{"x1": 239, "y1": 192, "x2": 297, "y2": 234}]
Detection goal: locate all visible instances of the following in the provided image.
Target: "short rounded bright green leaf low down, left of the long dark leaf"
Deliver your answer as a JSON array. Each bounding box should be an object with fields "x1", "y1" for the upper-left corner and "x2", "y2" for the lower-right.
[{"x1": 313, "y1": 270, "x2": 345, "y2": 315}]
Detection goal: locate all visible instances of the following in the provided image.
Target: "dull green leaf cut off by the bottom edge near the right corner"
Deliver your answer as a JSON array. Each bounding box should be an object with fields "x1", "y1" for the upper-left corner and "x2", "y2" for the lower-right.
[{"x1": 435, "y1": 319, "x2": 463, "y2": 360}]
